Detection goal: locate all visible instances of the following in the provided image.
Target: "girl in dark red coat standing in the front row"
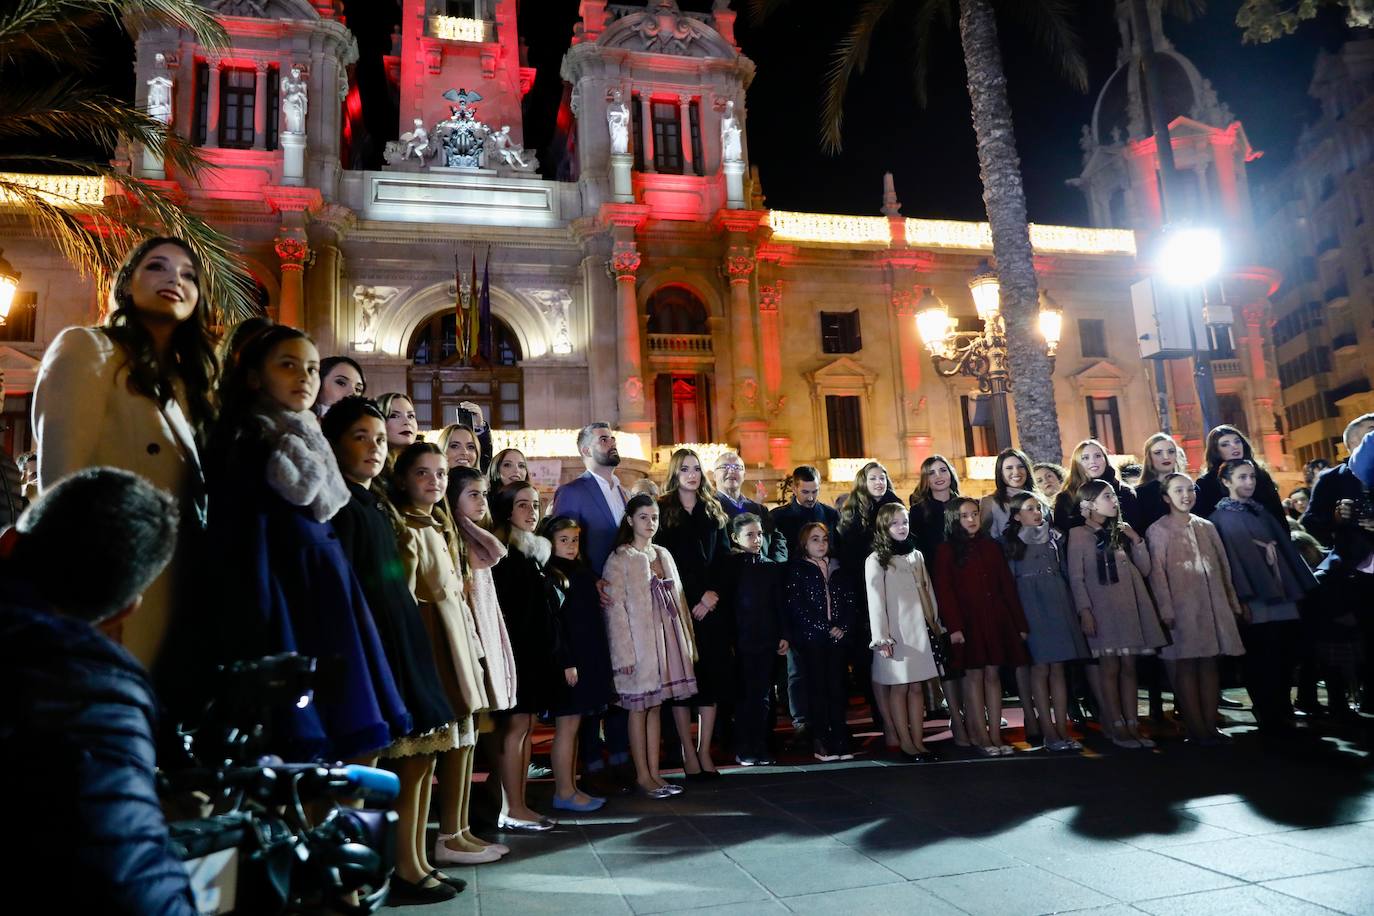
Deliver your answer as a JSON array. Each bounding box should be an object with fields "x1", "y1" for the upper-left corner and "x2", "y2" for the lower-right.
[{"x1": 934, "y1": 497, "x2": 1031, "y2": 757}]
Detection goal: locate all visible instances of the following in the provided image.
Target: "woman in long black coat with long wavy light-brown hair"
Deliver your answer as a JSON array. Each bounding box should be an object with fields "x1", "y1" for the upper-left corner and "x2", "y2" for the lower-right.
[{"x1": 654, "y1": 449, "x2": 735, "y2": 779}]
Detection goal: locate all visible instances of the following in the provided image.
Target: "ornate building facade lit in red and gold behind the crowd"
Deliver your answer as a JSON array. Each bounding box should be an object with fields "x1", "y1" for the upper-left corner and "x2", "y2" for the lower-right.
[{"x1": 0, "y1": 0, "x2": 1192, "y2": 492}]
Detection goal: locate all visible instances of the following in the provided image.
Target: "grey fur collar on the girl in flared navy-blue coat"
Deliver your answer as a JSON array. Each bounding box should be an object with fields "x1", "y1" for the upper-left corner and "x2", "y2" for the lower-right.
[{"x1": 256, "y1": 409, "x2": 349, "y2": 522}]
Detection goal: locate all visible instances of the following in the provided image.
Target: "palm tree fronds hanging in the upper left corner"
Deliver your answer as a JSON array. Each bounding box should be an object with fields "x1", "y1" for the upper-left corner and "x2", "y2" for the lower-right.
[{"x1": 0, "y1": 0, "x2": 260, "y2": 324}]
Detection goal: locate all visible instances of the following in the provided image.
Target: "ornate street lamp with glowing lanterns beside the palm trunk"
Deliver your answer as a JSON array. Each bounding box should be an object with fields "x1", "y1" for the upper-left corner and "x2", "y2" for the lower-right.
[{"x1": 916, "y1": 261, "x2": 1063, "y2": 452}]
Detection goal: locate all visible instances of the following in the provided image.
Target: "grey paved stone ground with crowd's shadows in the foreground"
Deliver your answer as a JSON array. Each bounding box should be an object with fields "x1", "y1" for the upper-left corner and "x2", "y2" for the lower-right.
[{"x1": 403, "y1": 694, "x2": 1374, "y2": 916}]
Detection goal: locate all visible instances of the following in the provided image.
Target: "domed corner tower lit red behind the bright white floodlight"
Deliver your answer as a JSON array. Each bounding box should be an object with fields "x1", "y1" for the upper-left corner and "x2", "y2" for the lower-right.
[{"x1": 1069, "y1": 0, "x2": 1287, "y2": 468}]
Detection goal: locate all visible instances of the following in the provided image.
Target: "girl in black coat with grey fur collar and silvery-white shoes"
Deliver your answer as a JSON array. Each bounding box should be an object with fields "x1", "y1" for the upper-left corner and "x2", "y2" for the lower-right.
[{"x1": 492, "y1": 482, "x2": 562, "y2": 832}]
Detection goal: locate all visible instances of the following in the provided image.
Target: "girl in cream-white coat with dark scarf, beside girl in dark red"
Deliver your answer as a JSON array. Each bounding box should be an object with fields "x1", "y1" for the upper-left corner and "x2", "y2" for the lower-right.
[{"x1": 864, "y1": 503, "x2": 941, "y2": 762}]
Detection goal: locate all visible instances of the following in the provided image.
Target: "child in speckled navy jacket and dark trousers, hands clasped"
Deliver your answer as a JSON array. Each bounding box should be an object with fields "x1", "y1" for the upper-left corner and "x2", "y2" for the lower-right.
[{"x1": 782, "y1": 522, "x2": 855, "y2": 762}]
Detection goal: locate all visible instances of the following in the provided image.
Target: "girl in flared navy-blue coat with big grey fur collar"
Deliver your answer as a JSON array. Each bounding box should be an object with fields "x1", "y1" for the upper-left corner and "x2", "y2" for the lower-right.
[{"x1": 207, "y1": 324, "x2": 412, "y2": 761}]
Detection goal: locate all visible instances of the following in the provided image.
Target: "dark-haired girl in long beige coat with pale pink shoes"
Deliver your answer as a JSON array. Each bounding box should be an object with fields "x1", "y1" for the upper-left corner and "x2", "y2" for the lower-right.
[{"x1": 392, "y1": 442, "x2": 508, "y2": 900}]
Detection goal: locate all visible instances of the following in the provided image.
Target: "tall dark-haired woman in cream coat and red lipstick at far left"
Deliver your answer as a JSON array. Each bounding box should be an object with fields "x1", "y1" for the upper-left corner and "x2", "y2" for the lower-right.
[{"x1": 33, "y1": 238, "x2": 218, "y2": 669}]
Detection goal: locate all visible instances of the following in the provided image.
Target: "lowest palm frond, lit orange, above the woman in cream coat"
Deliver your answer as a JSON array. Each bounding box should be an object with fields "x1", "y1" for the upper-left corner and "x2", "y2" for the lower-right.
[{"x1": 0, "y1": 154, "x2": 260, "y2": 324}]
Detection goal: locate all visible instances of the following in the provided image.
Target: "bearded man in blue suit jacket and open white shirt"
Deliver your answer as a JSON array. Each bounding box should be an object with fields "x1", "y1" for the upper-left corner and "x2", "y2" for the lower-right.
[{"x1": 550, "y1": 422, "x2": 633, "y2": 795}]
